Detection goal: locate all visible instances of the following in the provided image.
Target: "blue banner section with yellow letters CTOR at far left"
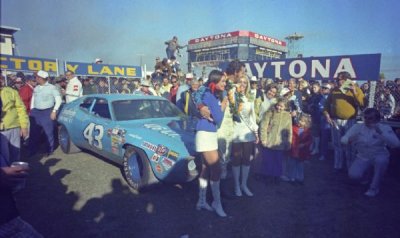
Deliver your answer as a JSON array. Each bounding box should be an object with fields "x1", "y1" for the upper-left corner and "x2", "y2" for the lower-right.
[{"x1": 0, "y1": 55, "x2": 58, "y2": 74}]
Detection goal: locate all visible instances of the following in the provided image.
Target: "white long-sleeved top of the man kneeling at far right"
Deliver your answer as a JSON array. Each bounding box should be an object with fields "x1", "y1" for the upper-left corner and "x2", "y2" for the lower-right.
[{"x1": 341, "y1": 123, "x2": 400, "y2": 160}]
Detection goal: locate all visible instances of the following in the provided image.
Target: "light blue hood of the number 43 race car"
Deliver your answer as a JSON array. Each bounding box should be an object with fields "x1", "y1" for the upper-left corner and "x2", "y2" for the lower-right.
[{"x1": 116, "y1": 118, "x2": 195, "y2": 156}]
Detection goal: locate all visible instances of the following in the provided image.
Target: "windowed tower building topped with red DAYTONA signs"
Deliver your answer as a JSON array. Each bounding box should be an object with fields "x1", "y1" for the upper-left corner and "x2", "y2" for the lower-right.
[{"x1": 187, "y1": 30, "x2": 287, "y2": 71}]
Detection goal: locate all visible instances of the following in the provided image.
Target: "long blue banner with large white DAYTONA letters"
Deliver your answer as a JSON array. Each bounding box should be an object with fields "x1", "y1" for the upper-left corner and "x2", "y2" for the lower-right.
[{"x1": 219, "y1": 54, "x2": 381, "y2": 80}]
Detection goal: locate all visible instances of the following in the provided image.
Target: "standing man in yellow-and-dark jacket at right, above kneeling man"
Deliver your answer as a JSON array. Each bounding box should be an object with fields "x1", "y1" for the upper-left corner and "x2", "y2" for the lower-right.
[{"x1": 324, "y1": 71, "x2": 364, "y2": 170}]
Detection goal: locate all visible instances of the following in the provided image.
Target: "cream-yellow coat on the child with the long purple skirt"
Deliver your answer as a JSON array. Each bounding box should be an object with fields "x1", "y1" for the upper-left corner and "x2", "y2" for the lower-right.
[{"x1": 260, "y1": 110, "x2": 292, "y2": 150}]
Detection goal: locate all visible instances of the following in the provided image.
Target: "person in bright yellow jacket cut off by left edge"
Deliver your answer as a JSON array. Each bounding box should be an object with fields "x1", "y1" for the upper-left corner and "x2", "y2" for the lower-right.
[{"x1": 0, "y1": 75, "x2": 29, "y2": 165}]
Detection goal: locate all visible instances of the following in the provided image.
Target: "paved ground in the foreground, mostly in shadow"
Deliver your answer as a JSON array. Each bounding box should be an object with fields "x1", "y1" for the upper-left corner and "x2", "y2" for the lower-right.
[{"x1": 17, "y1": 147, "x2": 400, "y2": 238}]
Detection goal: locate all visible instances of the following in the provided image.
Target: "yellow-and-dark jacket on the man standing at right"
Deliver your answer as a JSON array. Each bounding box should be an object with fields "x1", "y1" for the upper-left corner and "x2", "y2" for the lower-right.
[{"x1": 324, "y1": 87, "x2": 364, "y2": 120}]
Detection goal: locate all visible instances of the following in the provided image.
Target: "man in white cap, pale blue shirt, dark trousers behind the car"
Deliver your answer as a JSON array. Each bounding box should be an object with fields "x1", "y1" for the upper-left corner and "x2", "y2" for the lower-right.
[{"x1": 29, "y1": 70, "x2": 61, "y2": 155}]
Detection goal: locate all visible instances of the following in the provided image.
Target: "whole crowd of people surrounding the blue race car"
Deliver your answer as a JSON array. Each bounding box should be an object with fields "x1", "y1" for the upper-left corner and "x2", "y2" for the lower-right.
[{"x1": 0, "y1": 59, "x2": 400, "y2": 232}]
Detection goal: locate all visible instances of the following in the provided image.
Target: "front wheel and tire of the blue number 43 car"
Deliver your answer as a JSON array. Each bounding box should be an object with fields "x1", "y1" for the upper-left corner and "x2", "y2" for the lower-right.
[{"x1": 122, "y1": 145, "x2": 157, "y2": 191}]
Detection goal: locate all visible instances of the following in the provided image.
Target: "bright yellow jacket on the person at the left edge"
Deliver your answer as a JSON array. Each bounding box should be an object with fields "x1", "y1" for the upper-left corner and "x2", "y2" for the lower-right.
[{"x1": 0, "y1": 87, "x2": 29, "y2": 130}]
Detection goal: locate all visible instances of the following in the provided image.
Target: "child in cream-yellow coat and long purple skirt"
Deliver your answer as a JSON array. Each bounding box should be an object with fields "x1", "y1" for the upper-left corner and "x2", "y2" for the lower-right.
[{"x1": 260, "y1": 98, "x2": 292, "y2": 182}]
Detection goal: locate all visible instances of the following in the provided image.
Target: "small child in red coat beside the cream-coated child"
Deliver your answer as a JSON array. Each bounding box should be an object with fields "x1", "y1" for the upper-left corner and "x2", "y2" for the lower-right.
[{"x1": 288, "y1": 114, "x2": 312, "y2": 184}]
